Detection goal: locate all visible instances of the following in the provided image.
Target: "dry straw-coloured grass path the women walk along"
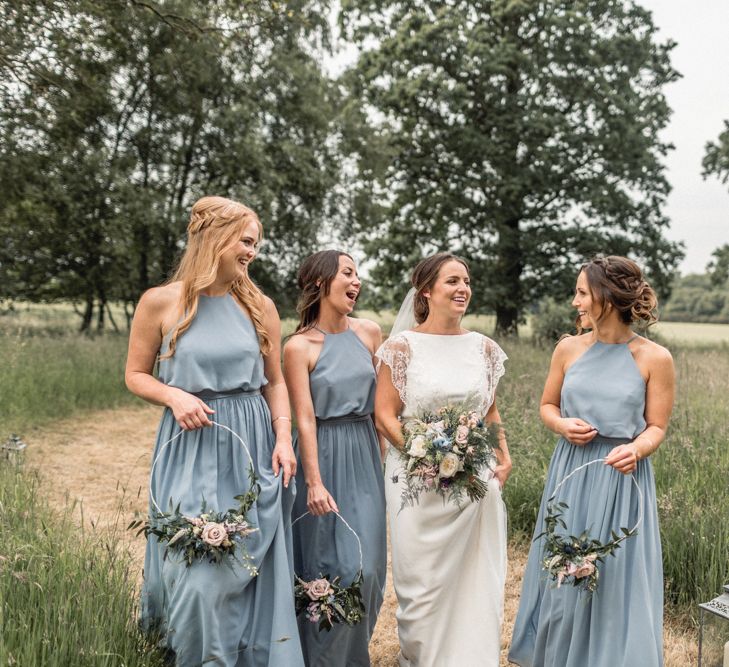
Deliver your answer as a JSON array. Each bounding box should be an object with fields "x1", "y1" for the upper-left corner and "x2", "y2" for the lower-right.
[{"x1": 27, "y1": 406, "x2": 697, "y2": 667}]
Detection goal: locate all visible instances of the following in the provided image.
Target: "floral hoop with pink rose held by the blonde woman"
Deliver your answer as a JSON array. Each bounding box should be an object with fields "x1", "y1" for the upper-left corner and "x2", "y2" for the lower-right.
[{"x1": 129, "y1": 421, "x2": 261, "y2": 577}]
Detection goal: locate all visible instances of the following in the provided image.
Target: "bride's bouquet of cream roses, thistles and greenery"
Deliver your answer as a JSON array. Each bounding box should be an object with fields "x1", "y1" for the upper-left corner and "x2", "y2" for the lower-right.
[{"x1": 393, "y1": 403, "x2": 501, "y2": 509}]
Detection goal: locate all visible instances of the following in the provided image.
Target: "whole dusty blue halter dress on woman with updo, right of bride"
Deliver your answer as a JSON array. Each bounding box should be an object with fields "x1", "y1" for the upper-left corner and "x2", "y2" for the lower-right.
[{"x1": 509, "y1": 339, "x2": 663, "y2": 667}]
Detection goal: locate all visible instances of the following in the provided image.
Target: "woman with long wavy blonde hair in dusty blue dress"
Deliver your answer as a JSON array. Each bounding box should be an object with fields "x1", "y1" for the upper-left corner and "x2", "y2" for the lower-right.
[{"x1": 126, "y1": 197, "x2": 303, "y2": 667}]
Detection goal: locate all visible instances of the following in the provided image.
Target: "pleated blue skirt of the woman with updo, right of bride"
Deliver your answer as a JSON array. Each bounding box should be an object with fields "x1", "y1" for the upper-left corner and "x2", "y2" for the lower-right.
[{"x1": 509, "y1": 438, "x2": 663, "y2": 667}]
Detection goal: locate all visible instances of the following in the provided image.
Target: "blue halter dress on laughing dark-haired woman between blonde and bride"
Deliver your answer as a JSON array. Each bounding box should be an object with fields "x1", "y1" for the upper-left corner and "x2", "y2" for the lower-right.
[{"x1": 293, "y1": 329, "x2": 387, "y2": 667}]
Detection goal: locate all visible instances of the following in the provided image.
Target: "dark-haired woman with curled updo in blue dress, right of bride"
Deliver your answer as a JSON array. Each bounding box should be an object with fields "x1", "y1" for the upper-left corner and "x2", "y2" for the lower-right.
[{"x1": 509, "y1": 256, "x2": 675, "y2": 667}]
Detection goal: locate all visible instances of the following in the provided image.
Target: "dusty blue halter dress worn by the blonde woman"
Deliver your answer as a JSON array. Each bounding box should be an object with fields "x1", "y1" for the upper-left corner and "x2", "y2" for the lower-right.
[{"x1": 141, "y1": 294, "x2": 303, "y2": 667}]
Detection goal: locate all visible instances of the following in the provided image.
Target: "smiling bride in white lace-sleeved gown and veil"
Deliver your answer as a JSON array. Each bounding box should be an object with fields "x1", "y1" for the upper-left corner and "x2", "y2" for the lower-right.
[{"x1": 375, "y1": 253, "x2": 511, "y2": 667}]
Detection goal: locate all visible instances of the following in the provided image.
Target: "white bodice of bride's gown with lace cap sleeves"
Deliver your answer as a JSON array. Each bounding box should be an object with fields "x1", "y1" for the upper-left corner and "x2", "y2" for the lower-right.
[{"x1": 376, "y1": 331, "x2": 507, "y2": 417}]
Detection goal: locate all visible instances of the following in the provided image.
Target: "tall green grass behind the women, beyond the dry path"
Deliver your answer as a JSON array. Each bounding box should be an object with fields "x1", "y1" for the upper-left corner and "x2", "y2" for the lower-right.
[{"x1": 0, "y1": 307, "x2": 729, "y2": 612}]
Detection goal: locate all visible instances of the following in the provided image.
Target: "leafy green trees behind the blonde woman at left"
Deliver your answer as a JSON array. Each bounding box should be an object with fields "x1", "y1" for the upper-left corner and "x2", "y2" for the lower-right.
[{"x1": 0, "y1": 0, "x2": 339, "y2": 330}]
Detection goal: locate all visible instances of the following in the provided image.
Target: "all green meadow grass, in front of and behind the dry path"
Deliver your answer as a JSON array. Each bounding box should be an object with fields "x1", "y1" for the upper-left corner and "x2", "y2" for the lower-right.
[{"x1": 0, "y1": 306, "x2": 729, "y2": 665}]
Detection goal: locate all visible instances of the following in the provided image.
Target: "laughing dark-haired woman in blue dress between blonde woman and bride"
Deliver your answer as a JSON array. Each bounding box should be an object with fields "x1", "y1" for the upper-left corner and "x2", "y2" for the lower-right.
[{"x1": 284, "y1": 250, "x2": 387, "y2": 667}]
